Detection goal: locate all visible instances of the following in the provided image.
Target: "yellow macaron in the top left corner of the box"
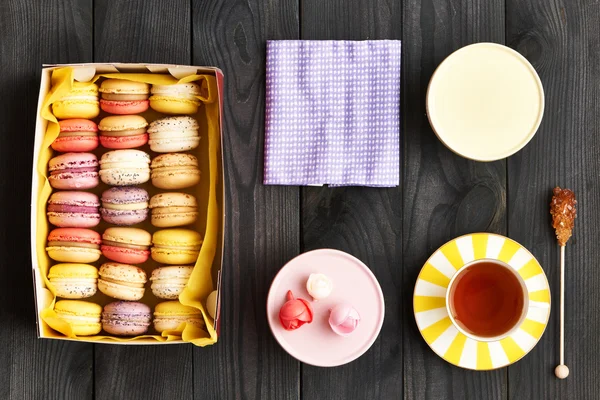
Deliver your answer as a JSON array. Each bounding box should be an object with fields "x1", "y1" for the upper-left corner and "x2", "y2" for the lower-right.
[{"x1": 52, "y1": 82, "x2": 100, "y2": 119}]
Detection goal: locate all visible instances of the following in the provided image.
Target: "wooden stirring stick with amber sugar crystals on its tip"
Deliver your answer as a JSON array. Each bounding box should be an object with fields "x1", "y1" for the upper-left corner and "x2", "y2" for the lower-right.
[{"x1": 550, "y1": 187, "x2": 577, "y2": 379}]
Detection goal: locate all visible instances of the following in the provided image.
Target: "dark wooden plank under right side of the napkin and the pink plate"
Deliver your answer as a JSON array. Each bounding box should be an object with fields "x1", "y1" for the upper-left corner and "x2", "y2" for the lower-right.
[{"x1": 301, "y1": 0, "x2": 404, "y2": 399}]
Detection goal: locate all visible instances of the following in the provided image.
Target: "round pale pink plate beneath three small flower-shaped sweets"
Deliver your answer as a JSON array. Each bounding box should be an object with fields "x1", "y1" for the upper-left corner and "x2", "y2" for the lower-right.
[{"x1": 267, "y1": 249, "x2": 385, "y2": 367}]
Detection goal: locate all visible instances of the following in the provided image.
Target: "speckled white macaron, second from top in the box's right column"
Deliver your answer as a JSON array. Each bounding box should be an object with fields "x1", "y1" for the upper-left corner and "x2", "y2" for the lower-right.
[{"x1": 148, "y1": 116, "x2": 200, "y2": 153}]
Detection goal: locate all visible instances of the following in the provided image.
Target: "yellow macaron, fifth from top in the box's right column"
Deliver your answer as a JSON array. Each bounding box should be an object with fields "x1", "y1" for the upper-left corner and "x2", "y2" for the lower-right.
[{"x1": 152, "y1": 228, "x2": 202, "y2": 265}]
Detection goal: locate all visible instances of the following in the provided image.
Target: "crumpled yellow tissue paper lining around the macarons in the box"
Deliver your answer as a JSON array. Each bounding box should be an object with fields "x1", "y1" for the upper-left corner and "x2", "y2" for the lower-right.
[{"x1": 36, "y1": 67, "x2": 222, "y2": 346}]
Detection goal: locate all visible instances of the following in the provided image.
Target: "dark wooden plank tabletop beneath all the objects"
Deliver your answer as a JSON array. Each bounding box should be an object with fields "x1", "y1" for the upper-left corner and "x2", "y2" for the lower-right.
[{"x1": 0, "y1": 0, "x2": 600, "y2": 400}]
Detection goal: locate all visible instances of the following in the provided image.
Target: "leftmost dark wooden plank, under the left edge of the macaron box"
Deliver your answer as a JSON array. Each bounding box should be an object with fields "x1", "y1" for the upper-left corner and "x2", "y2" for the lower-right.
[{"x1": 0, "y1": 0, "x2": 93, "y2": 399}]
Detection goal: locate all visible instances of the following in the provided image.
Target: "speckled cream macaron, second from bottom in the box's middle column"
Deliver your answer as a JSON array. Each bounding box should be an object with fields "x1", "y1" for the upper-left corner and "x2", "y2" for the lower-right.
[{"x1": 98, "y1": 263, "x2": 147, "y2": 300}]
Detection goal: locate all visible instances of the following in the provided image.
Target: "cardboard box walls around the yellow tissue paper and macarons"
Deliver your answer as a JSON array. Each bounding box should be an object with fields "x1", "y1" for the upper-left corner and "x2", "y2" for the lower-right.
[{"x1": 31, "y1": 63, "x2": 226, "y2": 346}]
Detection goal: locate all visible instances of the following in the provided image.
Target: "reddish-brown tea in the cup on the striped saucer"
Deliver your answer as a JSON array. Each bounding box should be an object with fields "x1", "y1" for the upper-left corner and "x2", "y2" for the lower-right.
[{"x1": 449, "y1": 261, "x2": 525, "y2": 337}]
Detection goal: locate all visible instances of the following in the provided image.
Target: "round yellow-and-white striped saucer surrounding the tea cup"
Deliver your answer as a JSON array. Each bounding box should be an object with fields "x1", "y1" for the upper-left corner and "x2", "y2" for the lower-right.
[{"x1": 413, "y1": 233, "x2": 550, "y2": 371}]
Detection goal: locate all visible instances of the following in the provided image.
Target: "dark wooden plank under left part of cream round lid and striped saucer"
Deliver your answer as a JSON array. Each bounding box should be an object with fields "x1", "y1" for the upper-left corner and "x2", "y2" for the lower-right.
[{"x1": 402, "y1": 0, "x2": 507, "y2": 399}]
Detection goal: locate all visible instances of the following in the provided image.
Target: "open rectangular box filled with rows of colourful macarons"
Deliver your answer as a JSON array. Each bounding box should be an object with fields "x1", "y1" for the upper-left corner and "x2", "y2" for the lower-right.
[{"x1": 31, "y1": 64, "x2": 225, "y2": 346}]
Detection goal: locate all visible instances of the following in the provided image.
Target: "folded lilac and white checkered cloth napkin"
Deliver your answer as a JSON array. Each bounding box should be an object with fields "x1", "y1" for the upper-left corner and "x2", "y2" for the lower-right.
[{"x1": 264, "y1": 40, "x2": 400, "y2": 187}]
